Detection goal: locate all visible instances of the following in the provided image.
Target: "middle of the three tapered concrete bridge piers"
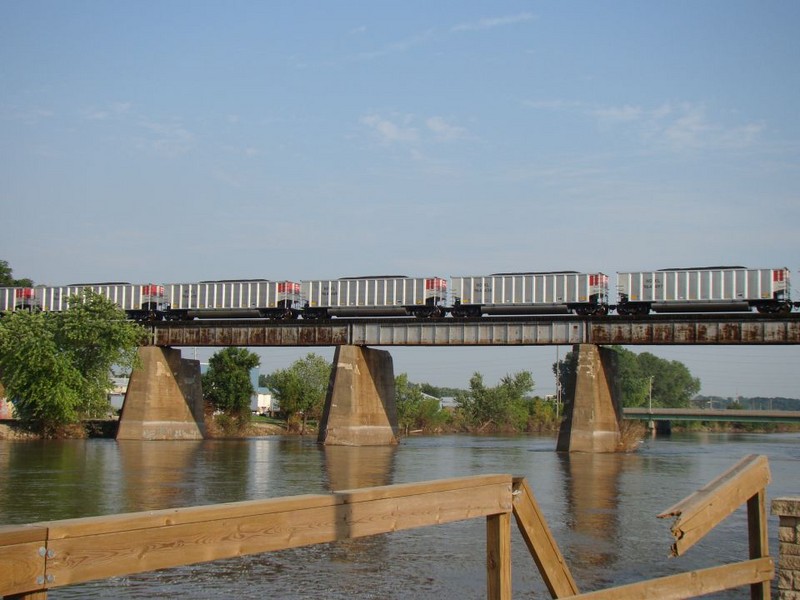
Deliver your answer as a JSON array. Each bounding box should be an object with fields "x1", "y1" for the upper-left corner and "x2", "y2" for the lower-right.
[{"x1": 318, "y1": 346, "x2": 398, "y2": 446}]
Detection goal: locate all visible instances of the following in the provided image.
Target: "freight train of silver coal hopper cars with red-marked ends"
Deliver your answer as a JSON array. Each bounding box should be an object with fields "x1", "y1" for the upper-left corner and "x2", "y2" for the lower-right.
[{"x1": 0, "y1": 267, "x2": 800, "y2": 321}]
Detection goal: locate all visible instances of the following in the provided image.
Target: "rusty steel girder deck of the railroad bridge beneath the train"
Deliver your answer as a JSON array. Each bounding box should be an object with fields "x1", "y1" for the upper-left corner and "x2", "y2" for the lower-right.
[{"x1": 149, "y1": 313, "x2": 800, "y2": 346}]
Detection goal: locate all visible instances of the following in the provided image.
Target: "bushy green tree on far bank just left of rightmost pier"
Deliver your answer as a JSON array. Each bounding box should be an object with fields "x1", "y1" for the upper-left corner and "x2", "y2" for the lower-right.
[{"x1": 456, "y1": 371, "x2": 534, "y2": 431}]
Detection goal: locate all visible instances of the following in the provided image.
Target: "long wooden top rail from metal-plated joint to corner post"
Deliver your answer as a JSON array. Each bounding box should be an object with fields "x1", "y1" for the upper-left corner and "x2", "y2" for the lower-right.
[{"x1": 47, "y1": 475, "x2": 512, "y2": 587}]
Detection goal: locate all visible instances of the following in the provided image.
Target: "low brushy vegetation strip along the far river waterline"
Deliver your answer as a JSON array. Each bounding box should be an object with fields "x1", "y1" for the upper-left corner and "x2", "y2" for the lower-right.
[{"x1": 0, "y1": 417, "x2": 800, "y2": 440}]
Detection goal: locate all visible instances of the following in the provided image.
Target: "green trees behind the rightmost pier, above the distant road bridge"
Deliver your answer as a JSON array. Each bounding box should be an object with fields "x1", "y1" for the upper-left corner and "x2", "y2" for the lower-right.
[{"x1": 553, "y1": 346, "x2": 700, "y2": 408}]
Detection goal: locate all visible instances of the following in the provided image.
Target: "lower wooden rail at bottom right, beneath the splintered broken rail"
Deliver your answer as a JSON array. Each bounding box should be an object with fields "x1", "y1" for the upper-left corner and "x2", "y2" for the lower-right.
[{"x1": 570, "y1": 557, "x2": 775, "y2": 600}]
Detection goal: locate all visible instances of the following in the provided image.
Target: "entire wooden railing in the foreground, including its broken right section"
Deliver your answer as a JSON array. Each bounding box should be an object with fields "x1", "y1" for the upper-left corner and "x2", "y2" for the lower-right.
[{"x1": 0, "y1": 457, "x2": 773, "y2": 600}]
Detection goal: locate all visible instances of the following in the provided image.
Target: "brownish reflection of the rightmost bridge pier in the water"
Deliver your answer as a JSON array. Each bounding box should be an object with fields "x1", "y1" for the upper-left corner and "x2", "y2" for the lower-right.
[{"x1": 559, "y1": 452, "x2": 622, "y2": 573}]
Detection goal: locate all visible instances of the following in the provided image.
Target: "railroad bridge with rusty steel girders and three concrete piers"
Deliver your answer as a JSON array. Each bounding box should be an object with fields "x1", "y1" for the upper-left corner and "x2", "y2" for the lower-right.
[{"x1": 117, "y1": 313, "x2": 800, "y2": 452}]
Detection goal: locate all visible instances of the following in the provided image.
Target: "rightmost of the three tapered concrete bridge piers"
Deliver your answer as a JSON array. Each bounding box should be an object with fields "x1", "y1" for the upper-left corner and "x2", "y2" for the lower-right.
[{"x1": 556, "y1": 344, "x2": 622, "y2": 452}]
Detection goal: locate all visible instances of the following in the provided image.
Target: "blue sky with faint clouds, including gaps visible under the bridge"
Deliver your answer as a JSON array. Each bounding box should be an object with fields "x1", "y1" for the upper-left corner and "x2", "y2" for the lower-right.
[{"x1": 0, "y1": 0, "x2": 800, "y2": 397}]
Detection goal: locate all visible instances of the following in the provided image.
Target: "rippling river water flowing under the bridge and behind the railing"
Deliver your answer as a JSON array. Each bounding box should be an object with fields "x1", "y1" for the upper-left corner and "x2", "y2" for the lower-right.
[{"x1": 0, "y1": 433, "x2": 800, "y2": 600}]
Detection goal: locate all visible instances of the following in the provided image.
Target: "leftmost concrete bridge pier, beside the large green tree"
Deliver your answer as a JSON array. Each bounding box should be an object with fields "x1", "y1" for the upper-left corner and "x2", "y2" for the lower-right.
[{"x1": 117, "y1": 346, "x2": 205, "y2": 440}]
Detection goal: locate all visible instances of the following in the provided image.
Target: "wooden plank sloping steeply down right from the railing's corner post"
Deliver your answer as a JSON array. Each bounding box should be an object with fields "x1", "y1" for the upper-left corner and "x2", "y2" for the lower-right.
[{"x1": 514, "y1": 477, "x2": 578, "y2": 598}]
